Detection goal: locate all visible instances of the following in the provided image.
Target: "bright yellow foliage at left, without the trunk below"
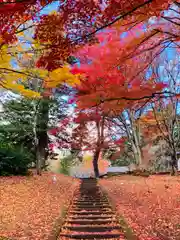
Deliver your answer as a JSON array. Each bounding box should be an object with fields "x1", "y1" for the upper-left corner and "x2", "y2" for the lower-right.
[{"x1": 0, "y1": 33, "x2": 79, "y2": 98}]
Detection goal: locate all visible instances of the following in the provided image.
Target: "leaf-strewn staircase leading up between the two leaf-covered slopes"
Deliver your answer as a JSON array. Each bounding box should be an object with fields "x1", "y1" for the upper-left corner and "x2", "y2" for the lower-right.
[{"x1": 59, "y1": 179, "x2": 125, "y2": 240}]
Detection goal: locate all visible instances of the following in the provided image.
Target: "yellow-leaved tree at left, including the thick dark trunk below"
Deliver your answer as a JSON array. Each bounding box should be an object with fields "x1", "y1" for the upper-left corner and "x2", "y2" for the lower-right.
[{"x1": 0, "y1": 28, "x2": 79, "y2": 174}]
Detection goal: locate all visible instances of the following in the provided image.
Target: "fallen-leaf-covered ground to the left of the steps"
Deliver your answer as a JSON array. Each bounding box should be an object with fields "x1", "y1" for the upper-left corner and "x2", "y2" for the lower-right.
[{"x1": 0, "y1": 173, "x2": 79, "y2": 240}]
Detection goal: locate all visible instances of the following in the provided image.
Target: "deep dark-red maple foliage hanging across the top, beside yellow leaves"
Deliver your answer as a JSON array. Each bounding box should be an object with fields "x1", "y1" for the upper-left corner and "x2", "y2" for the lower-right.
[{"x1": 36, "y1": 0, "x2": 172, "y2": 70}]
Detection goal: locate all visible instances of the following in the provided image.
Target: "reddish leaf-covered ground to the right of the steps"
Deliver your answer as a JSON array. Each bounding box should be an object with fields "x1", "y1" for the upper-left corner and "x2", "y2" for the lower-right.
[{"x1": 100, "y1": 176, "x2": 180, "y2": 240}]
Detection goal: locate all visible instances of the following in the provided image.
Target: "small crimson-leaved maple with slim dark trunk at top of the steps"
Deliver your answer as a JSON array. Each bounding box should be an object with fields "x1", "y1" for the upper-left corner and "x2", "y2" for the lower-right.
[{"x1": 49, "y1": 105, "x2": 116, "y2": 177}]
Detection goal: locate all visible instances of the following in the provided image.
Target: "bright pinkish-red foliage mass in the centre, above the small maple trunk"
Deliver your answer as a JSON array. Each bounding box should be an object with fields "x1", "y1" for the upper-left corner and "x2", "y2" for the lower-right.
[{"x1": 72, "y1": 28, "x2": 165, "y2": 112}]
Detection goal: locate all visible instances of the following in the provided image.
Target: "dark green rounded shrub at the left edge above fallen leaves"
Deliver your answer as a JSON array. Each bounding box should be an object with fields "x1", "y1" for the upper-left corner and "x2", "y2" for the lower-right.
[{"x1": 0, "y1": 144, "x2": 33, "y2": 176}]
